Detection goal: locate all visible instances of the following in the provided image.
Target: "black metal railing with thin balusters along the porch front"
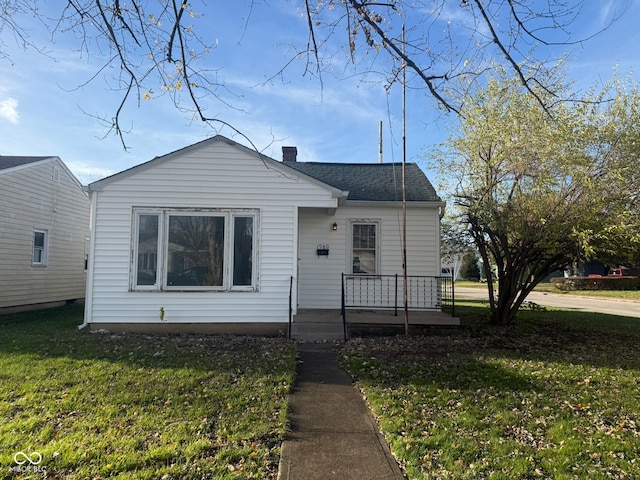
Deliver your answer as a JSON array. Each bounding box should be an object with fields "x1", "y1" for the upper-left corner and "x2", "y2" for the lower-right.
[{"x1": 342, "y1": 273, "x2": 455, "y2": 318}]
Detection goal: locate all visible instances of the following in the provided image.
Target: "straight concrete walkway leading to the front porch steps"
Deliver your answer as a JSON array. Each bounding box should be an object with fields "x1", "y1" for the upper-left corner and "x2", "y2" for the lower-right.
[{"x1": 278, "y1": 343, "x2": 405, "y2": 480}]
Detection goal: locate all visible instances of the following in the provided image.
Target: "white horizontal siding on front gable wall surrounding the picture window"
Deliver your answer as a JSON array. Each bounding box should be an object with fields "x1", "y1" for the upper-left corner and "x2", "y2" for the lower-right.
[{"x1": 85, "y1": 142, "x2": 337, "y2": 328}]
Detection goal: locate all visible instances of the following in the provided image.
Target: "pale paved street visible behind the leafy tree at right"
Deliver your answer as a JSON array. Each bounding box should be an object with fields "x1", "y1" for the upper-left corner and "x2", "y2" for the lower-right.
[{"x1": 455, "y1": 286, "x2": 640, "y2": 318}]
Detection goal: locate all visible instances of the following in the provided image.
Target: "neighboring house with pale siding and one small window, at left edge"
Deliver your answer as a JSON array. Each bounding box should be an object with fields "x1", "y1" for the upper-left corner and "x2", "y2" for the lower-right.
[{"x1": 0, "y1": 156, "x2": 90, "y2": 313}]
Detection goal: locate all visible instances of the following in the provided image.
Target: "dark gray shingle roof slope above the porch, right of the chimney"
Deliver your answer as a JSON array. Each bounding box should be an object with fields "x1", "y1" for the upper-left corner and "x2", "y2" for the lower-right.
[{"x1": 284, "y1": 162, "x2": 441, "y2": 202}]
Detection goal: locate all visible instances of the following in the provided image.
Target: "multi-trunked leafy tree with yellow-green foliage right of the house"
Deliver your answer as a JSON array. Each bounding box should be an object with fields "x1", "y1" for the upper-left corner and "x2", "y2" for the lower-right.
[{"x1": 442, "y1": 65, "x2": 640, "y2": 323}]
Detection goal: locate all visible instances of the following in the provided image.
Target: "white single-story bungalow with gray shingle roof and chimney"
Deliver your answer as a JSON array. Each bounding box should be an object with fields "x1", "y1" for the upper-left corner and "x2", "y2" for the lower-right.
[{"x1": 85, "y1": 136, "x2": 456, "y2": 334}]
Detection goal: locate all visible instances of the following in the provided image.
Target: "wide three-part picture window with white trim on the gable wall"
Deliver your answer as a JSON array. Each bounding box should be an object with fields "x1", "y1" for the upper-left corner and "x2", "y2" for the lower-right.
[{"x1": 132, "y1": 209, "x2": 258, "y2": 291}]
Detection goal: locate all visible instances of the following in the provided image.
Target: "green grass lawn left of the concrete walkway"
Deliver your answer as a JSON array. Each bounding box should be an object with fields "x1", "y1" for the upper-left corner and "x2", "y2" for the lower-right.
[{"x1": 0, "y1": 306, "x2": 295, "y2": 479}]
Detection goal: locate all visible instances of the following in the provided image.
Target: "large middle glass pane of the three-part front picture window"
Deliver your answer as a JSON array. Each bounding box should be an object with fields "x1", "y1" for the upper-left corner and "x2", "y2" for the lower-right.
[{"x1": 167, "y1": 215, "x2": 225, "y2": 287}]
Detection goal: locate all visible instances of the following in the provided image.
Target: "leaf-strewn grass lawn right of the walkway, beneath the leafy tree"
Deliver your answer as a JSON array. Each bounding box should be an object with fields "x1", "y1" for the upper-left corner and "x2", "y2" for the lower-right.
[{"x1": 342, "y1": 302, "x2": 640, "y2": 479}]
